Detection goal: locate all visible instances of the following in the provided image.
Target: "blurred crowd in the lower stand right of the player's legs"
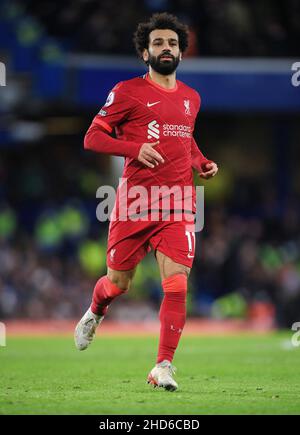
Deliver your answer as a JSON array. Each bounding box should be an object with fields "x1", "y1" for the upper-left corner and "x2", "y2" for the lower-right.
[{"x1": 192, "y1": 203, "x2": 300, "y2": 327}]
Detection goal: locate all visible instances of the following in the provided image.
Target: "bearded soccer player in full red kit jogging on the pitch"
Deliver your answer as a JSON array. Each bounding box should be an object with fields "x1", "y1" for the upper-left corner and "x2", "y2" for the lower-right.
[{"x1": 75, "y1": 13, "x2": 218, "y2": 391}]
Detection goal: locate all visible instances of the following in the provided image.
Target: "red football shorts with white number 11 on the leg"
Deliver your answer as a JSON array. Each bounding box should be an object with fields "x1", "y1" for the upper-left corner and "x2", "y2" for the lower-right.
[{"x1": 107, "y1": 215, "x2": 195, "y2": 270}]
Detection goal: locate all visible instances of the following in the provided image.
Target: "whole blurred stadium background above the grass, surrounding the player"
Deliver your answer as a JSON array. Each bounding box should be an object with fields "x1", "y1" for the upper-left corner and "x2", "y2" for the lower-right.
[{"x1": 0, "y1": 0, "x2": 300, "y2": 329}]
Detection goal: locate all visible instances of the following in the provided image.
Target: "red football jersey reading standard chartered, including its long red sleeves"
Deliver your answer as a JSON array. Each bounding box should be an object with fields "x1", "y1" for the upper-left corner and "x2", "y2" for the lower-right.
[{"x1": 85, "y1": 74, "x2": 208, "y2": 221}]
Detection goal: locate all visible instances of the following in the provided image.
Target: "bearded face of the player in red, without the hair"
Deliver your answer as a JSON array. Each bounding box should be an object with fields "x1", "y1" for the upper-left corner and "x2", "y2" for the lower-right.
[{"x1": 143, "y1": 29, "x2": 181, "y2": 75}]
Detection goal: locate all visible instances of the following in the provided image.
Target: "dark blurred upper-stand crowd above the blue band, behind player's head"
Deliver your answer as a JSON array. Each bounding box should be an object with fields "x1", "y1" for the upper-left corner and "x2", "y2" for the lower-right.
[{"x1": 22, "y1": 0, "x2": 300, "y2": 57}]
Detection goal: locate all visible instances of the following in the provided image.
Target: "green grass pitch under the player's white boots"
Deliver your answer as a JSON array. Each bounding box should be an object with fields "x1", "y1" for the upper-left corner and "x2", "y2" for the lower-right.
[{"x1": 0, "y1": 331, "x2": 300, "y2": 415}]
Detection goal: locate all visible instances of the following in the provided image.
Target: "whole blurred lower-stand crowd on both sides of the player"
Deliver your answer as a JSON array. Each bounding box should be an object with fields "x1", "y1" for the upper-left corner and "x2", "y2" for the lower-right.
[{"x1": 0, "y1": 146, "x2": 300, "y2": 327}]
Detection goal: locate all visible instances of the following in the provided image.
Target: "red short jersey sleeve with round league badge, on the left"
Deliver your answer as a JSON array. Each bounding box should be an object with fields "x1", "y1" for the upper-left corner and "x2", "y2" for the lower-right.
[{"x1": 97, "y1": 82, "x2": 131, "y2": 131}]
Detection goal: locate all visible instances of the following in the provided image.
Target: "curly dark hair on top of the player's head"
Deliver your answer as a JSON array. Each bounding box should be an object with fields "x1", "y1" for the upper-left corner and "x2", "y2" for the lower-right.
[{"x1": 133, "y1": 12, "x2": 188, "y2": 58}]
